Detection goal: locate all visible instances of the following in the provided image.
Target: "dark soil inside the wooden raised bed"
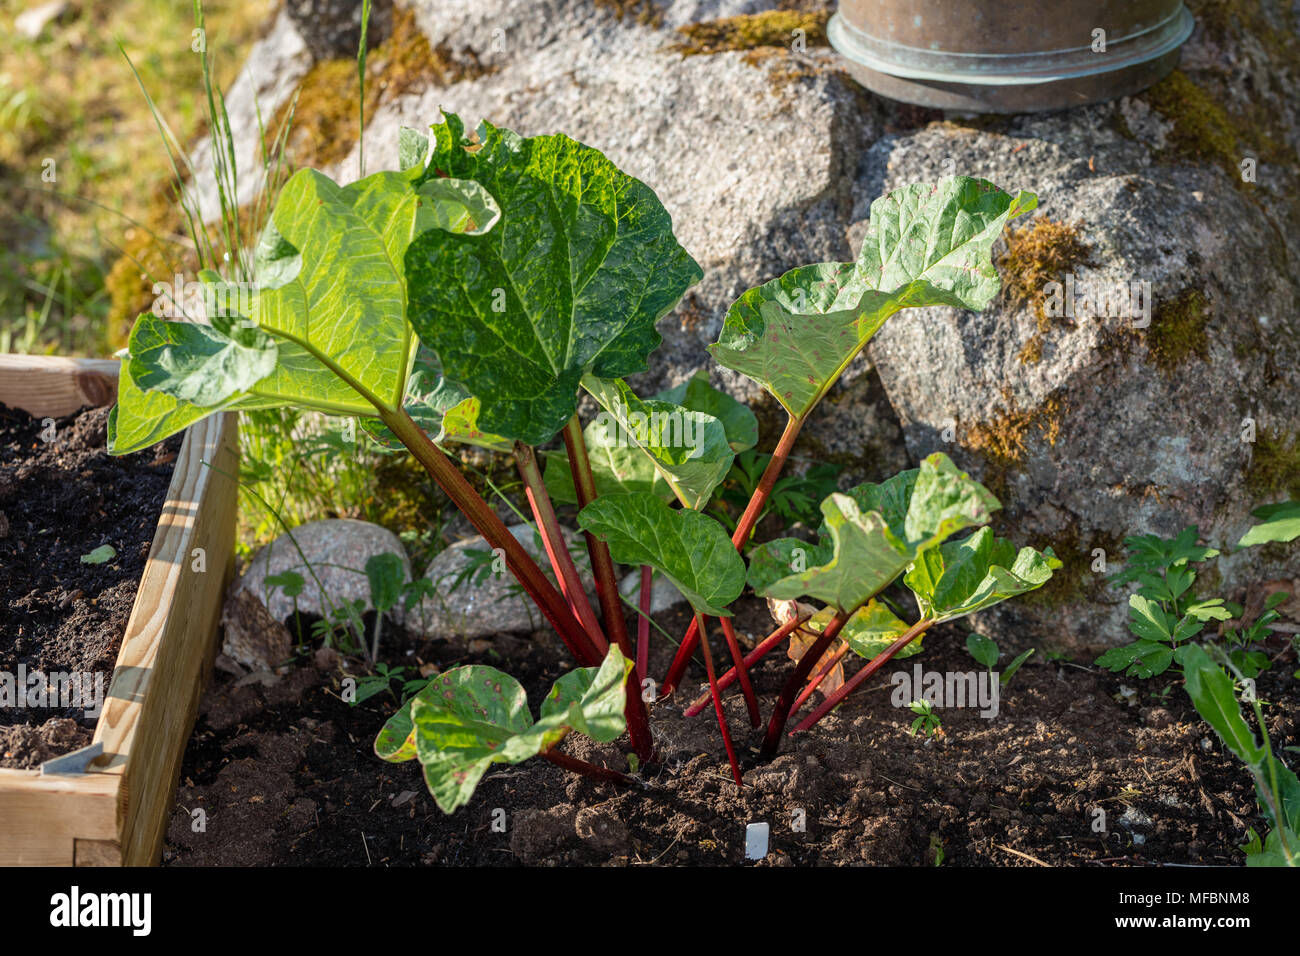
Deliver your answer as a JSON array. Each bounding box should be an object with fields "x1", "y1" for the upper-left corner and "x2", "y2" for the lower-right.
[{"x1": 0, "y1": 405, "x2": 181, "y2": 767}]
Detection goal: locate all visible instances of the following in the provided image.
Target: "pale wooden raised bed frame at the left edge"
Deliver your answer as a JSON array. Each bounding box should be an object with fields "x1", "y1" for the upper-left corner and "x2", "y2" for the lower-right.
[{"x1": 0, "y1": 355, "x2": 239, "y2": 866}]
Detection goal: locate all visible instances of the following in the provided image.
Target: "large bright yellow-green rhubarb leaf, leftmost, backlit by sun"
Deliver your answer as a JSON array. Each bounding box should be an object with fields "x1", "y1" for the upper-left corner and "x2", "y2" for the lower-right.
[{"x1": 111, "y1": 160, "x2": 499, "y2": 454}]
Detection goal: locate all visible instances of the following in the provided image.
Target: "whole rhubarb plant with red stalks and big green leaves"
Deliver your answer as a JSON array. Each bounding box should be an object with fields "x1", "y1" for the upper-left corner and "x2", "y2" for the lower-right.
[{"x1": 109, "y1": 106, "x2": 1056, "y2": 812}]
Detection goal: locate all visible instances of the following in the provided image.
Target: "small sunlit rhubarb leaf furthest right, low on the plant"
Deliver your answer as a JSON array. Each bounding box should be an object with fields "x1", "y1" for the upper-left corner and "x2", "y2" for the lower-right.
[{"x1": 904, "y1": 528, "x2": 1061, "y2": 622}]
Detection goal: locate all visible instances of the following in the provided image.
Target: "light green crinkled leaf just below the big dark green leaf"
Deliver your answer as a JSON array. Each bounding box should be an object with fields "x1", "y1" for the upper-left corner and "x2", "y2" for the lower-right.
[{"x1": 582, "y1": 376, "x2": 736, "y2": 511}]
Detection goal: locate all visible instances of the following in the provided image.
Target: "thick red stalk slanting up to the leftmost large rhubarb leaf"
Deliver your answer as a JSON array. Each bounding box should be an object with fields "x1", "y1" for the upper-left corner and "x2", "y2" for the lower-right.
[{"x1": 380, "y1": 408, "x2": 603, "y2": 671}]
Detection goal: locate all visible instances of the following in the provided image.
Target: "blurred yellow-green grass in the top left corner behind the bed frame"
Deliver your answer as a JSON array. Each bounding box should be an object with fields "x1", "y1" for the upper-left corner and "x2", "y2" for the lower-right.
[{"x1": 0, "y1": 0, "x2": 274, "y2": 355}]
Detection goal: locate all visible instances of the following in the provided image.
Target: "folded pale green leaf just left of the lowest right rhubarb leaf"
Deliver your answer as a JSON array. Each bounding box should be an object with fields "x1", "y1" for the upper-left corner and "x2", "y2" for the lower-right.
[{"x1": 750, "y1": 453, "x2": 998, "y2": 611}]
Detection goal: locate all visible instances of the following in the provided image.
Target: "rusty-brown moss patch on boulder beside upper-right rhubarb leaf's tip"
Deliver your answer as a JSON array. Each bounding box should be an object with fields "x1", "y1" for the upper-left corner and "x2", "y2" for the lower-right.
[{"x1": 997, "y1": 217, "x2": 1091, "y2": 364}]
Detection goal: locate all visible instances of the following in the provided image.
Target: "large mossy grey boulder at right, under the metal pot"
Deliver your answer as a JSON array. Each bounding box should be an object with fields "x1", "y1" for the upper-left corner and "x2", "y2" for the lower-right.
[{"x1": 853, "y1": 13, "x2": 1300, "y2": 653}]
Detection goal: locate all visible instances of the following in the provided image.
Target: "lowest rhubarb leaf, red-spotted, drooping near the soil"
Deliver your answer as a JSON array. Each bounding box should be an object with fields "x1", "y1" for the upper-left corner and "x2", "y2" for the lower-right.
[{"x1": 374, "y1": 646, "x2": 632, "y2": 813}]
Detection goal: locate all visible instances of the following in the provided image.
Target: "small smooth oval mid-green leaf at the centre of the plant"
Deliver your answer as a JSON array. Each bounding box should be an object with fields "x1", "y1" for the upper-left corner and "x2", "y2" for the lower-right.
[{"x1": 577, "y1": 493, "x2": 745, "y2": 618}]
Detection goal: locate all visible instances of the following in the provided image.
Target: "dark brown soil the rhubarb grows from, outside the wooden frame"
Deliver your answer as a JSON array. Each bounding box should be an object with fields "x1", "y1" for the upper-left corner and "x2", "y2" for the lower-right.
[{"x1": 164, "y1": 602, "x2": 1297, "y2": 866}]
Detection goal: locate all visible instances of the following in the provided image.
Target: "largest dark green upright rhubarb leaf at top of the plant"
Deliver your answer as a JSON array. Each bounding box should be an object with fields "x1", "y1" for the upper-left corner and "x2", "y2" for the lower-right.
[{"x1": 407, "y1": 113, "x2": 702, "y2": 445}]
